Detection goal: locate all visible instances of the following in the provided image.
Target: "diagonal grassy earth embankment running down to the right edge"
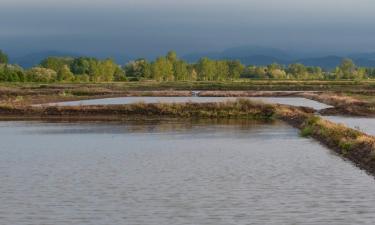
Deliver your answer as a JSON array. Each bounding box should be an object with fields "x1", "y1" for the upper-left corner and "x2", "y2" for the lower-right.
[{"x1": 276, "y1": 105, "x2": 375, "y2": 175}]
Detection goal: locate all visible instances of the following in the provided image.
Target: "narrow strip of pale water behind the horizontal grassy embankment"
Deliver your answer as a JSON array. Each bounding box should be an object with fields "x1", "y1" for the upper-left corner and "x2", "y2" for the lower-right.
[{"x1": 47, "y1": 97, "x2": 330, "y2": 110}]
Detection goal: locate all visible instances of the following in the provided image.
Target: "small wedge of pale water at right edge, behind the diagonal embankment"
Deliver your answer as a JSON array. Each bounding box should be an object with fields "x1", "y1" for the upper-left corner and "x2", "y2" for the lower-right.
[{"x1": 323, "y1": 116, "x2": 375, "y2": 136}]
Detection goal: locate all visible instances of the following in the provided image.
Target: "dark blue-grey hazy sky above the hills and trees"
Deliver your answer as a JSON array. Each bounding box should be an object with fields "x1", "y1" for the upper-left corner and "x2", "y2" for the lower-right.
[{"x1": 0, "y1": 0, "x2": 375, "y2": 57}]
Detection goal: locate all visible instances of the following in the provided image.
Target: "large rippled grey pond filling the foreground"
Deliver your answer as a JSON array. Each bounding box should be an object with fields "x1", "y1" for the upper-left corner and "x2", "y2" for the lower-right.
[{"x1": 0, "y1": 121, "x2": 375, "y2": 225}]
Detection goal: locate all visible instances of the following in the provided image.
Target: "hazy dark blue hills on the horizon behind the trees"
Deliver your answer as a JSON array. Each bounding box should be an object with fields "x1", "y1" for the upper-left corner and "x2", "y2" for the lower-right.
[{"x1": 10, "y1": 46, "x2": 375, "y2": 70}]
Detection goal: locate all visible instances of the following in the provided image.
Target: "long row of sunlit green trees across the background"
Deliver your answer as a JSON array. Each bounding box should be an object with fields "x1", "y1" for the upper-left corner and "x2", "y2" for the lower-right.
[{"x1": 0, "y1": 50, "x2": 375, "y2": 82}]
